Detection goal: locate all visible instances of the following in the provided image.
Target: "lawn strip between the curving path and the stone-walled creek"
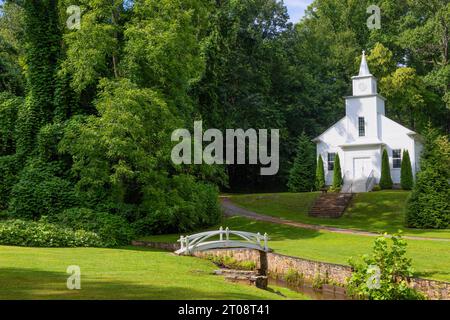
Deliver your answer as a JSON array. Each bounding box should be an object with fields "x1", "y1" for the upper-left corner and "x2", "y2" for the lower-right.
[{"x1": 143, "y1": 217, "x2": 450, "y2": 281}]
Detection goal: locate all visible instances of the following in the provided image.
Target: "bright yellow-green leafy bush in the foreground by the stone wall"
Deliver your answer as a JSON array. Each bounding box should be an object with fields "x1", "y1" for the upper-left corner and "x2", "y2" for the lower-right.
[{"x1": 347, "y1": 235, "x2": 424, "y2": 300}]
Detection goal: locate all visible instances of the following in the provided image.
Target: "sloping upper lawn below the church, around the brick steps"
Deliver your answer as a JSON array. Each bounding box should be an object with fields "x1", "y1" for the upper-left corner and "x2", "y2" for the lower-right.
[{"x1": 231, "y1": 191, "x2": 450, "y2": 239}]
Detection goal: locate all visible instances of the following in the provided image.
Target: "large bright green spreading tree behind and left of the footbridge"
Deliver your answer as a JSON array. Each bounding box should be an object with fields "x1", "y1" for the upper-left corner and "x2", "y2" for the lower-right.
[{"x1": 60, "y1": 79, "x2": 220, "y2": 234}]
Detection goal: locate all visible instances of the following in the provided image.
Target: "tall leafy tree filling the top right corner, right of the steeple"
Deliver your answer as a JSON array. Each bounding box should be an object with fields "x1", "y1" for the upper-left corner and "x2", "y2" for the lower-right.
[{"x1": 397, "y1": 0, "x2": 450, "y2": 133}]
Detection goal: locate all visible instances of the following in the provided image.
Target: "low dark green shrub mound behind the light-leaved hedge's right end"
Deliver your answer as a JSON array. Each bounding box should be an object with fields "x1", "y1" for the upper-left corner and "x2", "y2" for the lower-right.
[{"x1": 50, "y1": 208, "x2": 134, "y2": 247}]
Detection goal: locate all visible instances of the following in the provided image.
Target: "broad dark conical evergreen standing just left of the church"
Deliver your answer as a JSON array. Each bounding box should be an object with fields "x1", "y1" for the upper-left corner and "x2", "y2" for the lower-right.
[{"x1": 288, "y1": 134, "x2": 316, "y2": 192}]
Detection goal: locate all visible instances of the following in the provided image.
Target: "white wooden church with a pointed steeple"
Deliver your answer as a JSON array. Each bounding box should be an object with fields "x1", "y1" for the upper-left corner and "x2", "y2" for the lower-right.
[{"x1": 313, "y1": 52, "x2": 423, "y2": 192}]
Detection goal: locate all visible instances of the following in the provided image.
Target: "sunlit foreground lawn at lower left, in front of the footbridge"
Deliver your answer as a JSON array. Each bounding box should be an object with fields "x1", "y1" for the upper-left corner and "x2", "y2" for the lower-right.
[{"x1": 0, "y1": 246, "x2": 305, "y2": 299}]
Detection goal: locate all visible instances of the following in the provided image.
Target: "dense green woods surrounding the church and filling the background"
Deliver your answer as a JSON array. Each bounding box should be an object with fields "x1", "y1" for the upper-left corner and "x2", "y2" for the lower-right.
[{"x1": 0, "y1": 0, "x2": 450, "y2": 240}]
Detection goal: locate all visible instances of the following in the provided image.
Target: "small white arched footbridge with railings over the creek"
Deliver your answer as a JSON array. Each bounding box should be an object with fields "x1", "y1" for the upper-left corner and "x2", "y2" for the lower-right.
[{"x1": 175, "y1": 227, "x2": 270, "y2": 255}]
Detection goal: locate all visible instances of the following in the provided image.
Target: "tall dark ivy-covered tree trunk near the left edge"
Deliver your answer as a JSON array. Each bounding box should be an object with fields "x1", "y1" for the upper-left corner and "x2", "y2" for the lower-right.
[{"x1": 17, "y1": 0, "x2": 61, "y2": 157}]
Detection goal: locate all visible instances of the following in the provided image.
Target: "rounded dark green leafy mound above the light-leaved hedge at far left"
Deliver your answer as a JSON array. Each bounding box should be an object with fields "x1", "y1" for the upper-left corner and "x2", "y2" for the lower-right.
[{"x1": 8, "y1": 159, "x2": 77, "y2": 220}]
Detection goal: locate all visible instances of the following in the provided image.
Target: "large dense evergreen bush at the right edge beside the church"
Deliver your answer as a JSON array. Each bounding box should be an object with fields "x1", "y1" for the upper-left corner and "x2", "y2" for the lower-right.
[{"x1": 406, "y1": 136, "x2": 450, "y2": 229}]
